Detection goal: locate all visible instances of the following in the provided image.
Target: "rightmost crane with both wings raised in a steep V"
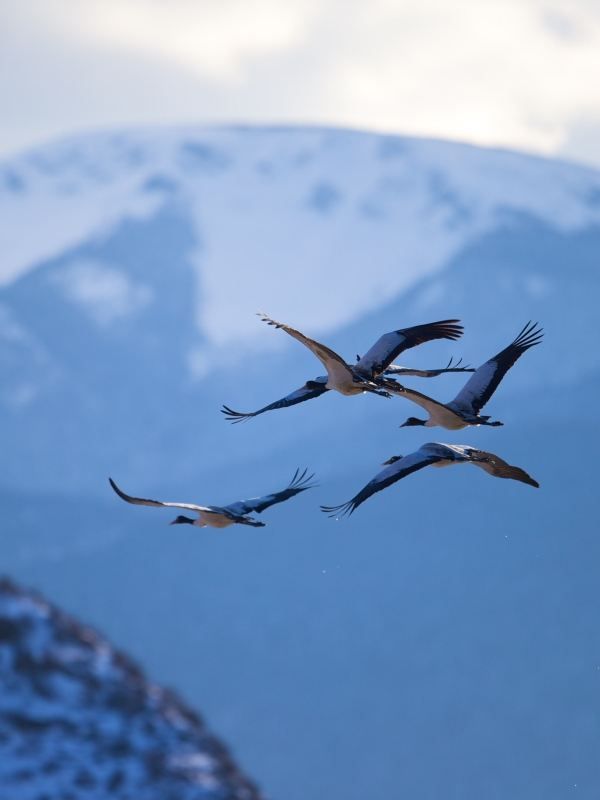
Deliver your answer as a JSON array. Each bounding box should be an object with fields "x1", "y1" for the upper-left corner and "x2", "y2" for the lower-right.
[{"x1": 394, "y1": 322, "x2": 543, "y2": 431}]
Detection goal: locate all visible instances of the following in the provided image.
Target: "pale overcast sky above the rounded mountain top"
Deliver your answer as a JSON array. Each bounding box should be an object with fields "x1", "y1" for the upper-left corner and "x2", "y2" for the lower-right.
[{"x1": 0, "y1": 0, "x2": 600, "y2": 166}]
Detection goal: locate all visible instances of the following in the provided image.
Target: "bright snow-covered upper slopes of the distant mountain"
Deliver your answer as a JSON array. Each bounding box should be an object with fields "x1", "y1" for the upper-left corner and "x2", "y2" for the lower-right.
[{"x1": 0, "y1": 128, "x2": 600, "y2": 360}]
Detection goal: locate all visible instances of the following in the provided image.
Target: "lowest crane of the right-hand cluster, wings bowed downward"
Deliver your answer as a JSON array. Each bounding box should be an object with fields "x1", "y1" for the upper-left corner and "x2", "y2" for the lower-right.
[{"x1": 321, "y1": 442, "x2": 539, "y2": 517}]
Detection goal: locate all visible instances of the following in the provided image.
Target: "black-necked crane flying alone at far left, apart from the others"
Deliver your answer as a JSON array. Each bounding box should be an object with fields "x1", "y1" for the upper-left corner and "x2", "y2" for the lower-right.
[{"x1": 108, "y1": 469, "x2": 316, "y2": 528}]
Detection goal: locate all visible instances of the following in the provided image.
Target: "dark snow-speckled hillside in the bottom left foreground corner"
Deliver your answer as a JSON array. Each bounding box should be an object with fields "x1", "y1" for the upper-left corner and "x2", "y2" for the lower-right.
[{"x1": 0, "y1": 579, "x2": 259, "y2": 800}]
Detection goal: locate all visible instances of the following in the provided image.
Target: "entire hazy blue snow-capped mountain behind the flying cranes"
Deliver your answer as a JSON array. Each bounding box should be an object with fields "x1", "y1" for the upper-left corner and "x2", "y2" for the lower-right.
[{"x1": 0, "y1": 128, "x2": 600, "y2": 800}]
